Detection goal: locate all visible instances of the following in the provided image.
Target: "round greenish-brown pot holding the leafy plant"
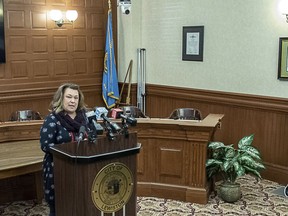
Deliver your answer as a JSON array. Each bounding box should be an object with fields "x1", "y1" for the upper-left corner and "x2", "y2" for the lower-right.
[{"x1": 219, "y1": 182, "x2": 242, "y2": 203}]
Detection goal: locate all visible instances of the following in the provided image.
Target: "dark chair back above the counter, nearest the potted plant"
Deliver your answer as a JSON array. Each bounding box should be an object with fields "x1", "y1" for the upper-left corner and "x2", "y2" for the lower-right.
[{"x1": 169, "y1": 108, "x2": 202, "y2": 120}]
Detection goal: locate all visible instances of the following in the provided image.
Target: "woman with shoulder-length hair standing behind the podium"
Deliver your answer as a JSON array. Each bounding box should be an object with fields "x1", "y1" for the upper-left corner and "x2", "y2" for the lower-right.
[{"x1": 40, "y1": 83, "x2": 86, "y2": 216}]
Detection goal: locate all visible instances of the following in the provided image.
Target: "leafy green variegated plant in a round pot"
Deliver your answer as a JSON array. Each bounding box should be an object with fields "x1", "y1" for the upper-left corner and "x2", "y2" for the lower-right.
[{"x1": 206, "y1": 134, "x2": 265, "y2": 202}]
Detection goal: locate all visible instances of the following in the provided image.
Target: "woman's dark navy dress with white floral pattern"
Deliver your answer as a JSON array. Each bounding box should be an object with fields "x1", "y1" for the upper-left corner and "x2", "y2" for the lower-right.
[{"x1": 40, "y1": 113, "x2": 74, "y2": 205}]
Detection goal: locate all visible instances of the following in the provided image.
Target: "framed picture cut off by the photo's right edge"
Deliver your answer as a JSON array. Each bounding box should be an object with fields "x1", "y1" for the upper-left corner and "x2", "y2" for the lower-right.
[{"x1": 278, "y1": 37, "x2": 288, "y2": 81}]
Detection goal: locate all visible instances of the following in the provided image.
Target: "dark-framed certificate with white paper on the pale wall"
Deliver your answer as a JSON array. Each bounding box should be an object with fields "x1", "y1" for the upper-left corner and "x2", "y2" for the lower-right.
[{"x1": 182, "y1": 26, "x2": 204, "y2": 61}]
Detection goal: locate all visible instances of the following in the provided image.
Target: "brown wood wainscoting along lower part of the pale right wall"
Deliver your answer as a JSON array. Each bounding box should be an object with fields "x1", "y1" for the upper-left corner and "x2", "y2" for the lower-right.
[{"x1": 142, "y1": 84, "x2": 288, "y2": 185}]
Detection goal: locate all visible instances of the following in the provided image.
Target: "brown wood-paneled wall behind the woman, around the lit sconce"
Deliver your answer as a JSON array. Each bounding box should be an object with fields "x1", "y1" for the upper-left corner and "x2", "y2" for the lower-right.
[{"x1": 0, "y1": 0, "x2": 117, "y2": 121}]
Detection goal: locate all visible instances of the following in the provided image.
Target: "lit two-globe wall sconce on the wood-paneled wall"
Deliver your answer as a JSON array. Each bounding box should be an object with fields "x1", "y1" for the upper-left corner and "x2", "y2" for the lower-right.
[{"x1": 50, "y1": 10, "x2": 78, "y2": 27}]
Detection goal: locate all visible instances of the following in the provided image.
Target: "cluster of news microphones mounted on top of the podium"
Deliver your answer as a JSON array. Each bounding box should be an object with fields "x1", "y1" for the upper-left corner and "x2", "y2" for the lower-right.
[{"x1": 78, "y1": 107, "x2": 137, "y2": 142}]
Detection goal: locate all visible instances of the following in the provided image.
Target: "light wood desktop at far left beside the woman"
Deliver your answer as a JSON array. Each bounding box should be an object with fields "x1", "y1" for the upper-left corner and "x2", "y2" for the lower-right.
[{"x1": 0, "y1": 140, "x2": 44, "y2": 179}]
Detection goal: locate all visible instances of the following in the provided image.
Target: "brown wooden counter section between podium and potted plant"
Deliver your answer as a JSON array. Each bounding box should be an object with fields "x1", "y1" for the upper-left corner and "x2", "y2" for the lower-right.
[{"x1": 130, "y1": 114, "x2": 224, "y2": 204}]
